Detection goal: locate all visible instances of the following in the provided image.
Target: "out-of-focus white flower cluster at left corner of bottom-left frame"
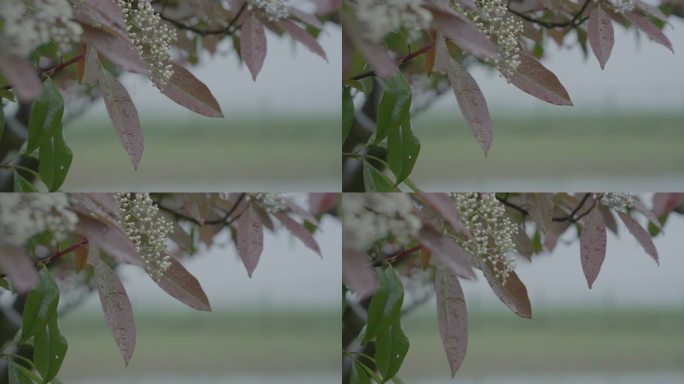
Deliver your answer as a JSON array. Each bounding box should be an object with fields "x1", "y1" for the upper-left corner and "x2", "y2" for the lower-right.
[{"x1": 0, "y1": 193, "x2": 78, "y2": 246}]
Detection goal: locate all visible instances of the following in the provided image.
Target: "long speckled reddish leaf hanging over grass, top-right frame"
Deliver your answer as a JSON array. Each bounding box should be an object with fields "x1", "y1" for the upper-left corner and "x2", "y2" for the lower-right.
[{"x1": 435, "y1": 37, "x2": 493, "y2": 156}]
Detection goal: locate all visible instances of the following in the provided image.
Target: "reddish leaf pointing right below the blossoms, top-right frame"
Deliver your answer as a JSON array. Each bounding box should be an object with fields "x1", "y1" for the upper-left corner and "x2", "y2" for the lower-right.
[{"x1": 510, "y1": 52, "x2": 572, "y2": 105}]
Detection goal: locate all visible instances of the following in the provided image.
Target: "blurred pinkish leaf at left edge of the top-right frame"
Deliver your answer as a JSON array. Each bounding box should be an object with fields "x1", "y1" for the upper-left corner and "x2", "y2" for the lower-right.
[{"x1": 342, "y1": 13, "x2": 399, "y2": 79}]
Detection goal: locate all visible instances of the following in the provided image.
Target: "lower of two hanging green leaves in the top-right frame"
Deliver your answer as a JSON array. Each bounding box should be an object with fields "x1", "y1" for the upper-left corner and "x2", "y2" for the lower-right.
[{"x1": 387, "y1": 121, "x2": 420, "y2": 185}]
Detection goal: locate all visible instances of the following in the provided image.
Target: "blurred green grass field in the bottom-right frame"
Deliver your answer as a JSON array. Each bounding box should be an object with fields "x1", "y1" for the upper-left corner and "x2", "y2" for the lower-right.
[{"x1": 401, "y1": 306, "x2": 684, "y2": 383}]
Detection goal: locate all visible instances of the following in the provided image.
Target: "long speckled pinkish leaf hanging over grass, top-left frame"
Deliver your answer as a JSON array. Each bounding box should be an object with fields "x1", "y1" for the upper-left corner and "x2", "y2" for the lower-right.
[{"x1": 99, "y1": 69, "x2": 144, "y2": 169}]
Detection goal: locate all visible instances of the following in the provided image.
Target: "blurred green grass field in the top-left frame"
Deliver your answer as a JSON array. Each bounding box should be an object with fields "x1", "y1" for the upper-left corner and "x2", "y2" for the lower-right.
[{"x1": 63, "y1": 112, "x2": 341, "y2": 192}]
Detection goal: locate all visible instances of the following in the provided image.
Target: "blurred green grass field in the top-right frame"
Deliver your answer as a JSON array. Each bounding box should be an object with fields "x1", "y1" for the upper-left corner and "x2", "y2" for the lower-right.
[{"x1": 412, "y1": 110, "x2": 684, "y2": 190}]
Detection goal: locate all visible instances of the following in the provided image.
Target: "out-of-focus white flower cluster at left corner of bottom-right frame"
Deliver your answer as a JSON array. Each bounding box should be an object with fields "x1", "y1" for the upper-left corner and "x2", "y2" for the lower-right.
[{"x1": 342, "y1": 193, "x2": 423, "y2": 251}]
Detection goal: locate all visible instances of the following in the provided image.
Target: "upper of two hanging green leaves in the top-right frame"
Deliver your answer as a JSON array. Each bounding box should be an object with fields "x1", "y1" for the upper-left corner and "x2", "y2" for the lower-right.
[{"x1": 375, "y1": 73, "x2": 412, "y2": 144}]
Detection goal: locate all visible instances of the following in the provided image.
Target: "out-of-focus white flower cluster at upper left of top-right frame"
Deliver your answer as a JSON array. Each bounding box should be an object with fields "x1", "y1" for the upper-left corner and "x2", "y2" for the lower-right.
[{"x1": 356, "y1": 0, "x2": 432, "y2": 42}]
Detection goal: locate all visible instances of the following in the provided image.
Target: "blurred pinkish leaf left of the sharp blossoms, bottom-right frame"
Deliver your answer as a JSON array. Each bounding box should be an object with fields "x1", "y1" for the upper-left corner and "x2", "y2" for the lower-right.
[{"x1": 418, "y1": 227, "x2": 476, "y2": 280}]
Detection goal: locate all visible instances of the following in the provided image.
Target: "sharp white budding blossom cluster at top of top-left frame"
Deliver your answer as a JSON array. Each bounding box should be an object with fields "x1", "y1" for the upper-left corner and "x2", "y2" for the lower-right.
[{"x1": 116, "y1": 0, "x2": 178, "y2": 90}]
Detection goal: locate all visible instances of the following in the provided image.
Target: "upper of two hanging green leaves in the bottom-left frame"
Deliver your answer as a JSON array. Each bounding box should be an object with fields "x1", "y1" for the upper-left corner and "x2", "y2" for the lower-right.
[{"x1": 21, "y1": 267, "x2": 59, "y2": 343}]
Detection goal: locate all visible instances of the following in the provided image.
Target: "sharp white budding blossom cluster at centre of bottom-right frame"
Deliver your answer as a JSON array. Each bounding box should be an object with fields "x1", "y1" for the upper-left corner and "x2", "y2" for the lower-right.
[{"x1": 452, "y1": 193, "x2": 517, "y2": 282}]
